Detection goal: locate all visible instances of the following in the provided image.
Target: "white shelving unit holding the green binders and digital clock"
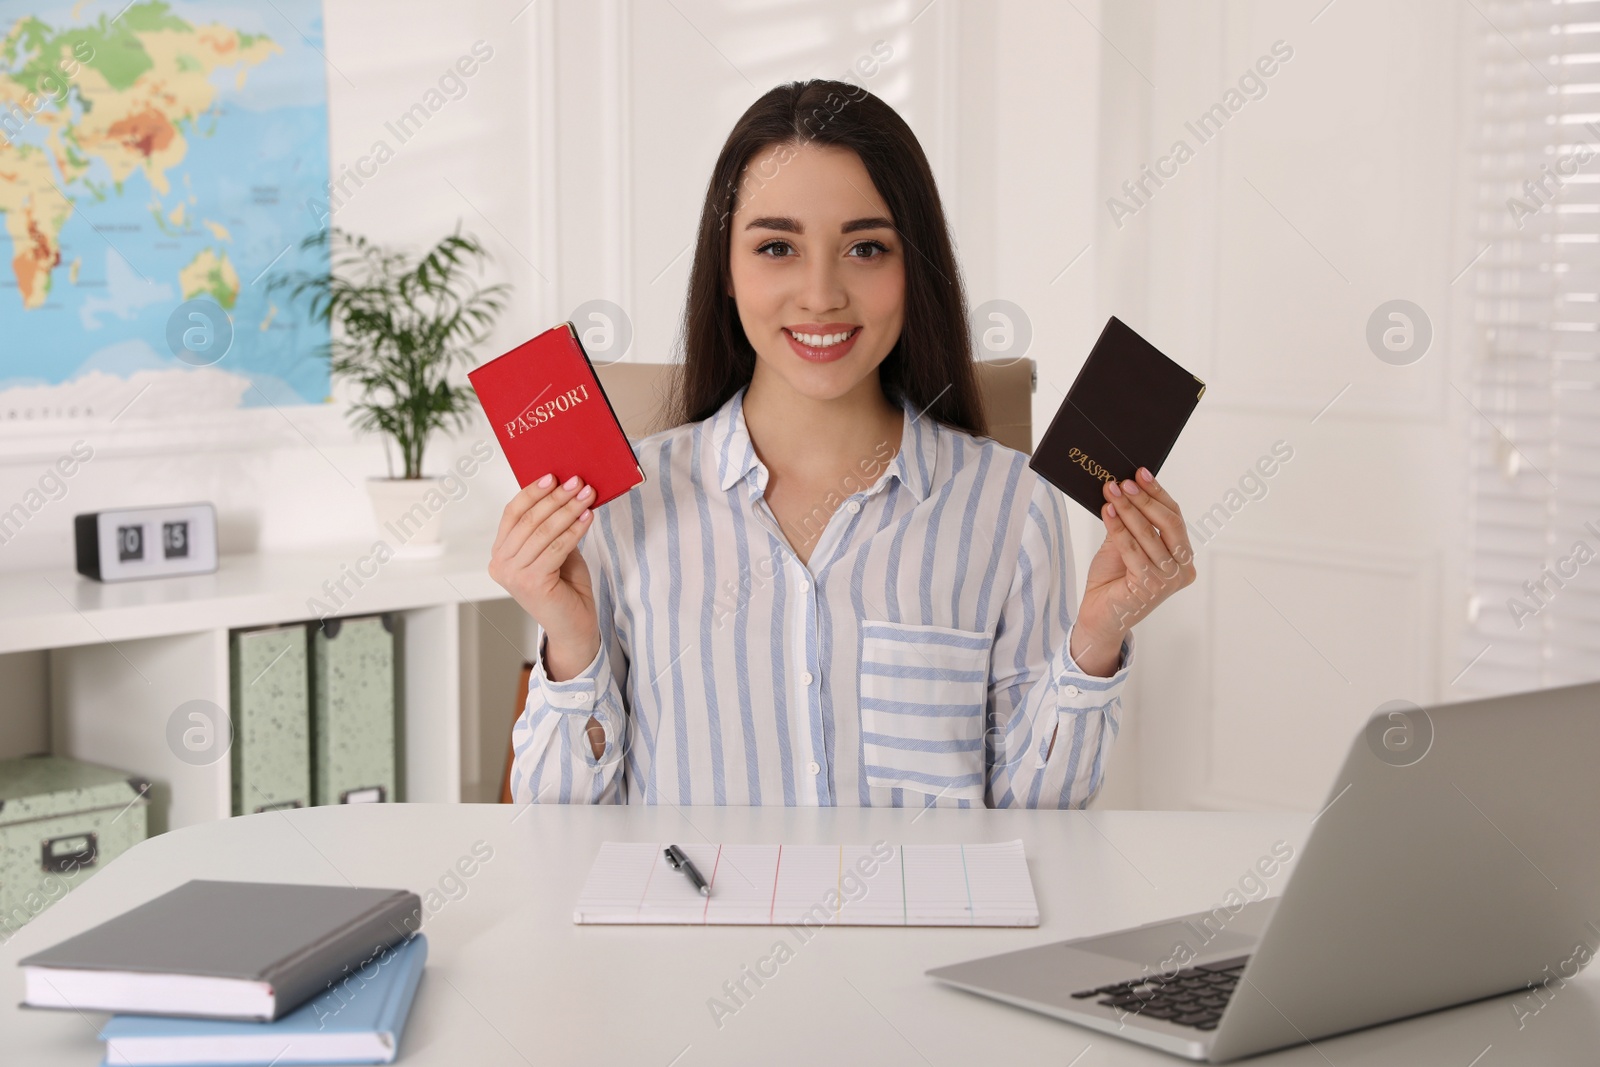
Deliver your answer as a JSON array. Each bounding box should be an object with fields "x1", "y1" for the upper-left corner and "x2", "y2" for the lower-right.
[{"x1": 0, "y1": 544, "x2": 534, "y2": 833}]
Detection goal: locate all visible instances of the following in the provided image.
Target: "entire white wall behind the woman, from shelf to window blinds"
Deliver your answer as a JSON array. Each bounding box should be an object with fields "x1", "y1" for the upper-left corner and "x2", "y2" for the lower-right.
[{"x1": 0, "y1": 0, "x2": 1475, "y2": 808}]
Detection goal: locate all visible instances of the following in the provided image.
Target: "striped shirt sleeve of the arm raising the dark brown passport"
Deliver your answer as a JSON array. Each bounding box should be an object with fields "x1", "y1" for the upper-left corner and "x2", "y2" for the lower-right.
[{"x1": 984, "y1": 478, "x2": 1133, "y2": 808}]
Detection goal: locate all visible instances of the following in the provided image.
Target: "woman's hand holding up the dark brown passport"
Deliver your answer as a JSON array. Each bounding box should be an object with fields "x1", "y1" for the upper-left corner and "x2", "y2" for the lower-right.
[{"x1": 1070, "y1": 467, "x2": 1195, "y2": 677}]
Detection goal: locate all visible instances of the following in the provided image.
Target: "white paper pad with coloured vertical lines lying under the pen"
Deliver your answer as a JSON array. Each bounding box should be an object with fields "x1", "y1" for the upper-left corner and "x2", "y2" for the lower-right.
[{"x1": 573, "y1": 840, "x2": 1038, "y2": 926}]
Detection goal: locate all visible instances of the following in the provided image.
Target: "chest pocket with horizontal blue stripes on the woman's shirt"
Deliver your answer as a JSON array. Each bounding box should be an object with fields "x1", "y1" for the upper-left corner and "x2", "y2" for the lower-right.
[{"x1": 861, "y1": 621, "x2": 990, "y2": 801}]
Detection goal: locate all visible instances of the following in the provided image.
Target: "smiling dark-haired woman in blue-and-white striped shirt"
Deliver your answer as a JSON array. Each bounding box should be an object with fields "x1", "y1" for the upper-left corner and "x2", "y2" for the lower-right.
[{"x1": 490, "y1": 80, "x2": 1195, "y2": 808}]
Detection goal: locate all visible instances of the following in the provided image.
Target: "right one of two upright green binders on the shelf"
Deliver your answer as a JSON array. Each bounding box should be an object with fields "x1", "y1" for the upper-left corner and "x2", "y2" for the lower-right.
[{"x1": 310, "y1": 614, "x2": 400, "y2": 805}]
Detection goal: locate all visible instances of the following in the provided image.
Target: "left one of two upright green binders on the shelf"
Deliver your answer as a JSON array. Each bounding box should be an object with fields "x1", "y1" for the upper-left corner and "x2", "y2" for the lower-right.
[{"x1": 229, "y1": 622, "x2": 310, "y2": 816}]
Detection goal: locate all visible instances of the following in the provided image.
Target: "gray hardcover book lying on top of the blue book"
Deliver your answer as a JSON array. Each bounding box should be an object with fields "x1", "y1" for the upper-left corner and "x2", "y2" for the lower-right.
[{"x1": 18, "y1": 880, "x2": 422, "y2": 1021}]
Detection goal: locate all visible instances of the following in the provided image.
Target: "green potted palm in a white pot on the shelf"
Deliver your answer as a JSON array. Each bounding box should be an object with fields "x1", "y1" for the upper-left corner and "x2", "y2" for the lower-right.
[{"x1": 270, "y1": 226, "x2": 507, "y2": 557}]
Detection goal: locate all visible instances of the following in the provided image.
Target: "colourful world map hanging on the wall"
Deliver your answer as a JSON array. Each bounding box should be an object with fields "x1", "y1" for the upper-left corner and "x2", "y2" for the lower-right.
[{"x1": 0, "y1": 0, "x2": 328, "y2": 424}]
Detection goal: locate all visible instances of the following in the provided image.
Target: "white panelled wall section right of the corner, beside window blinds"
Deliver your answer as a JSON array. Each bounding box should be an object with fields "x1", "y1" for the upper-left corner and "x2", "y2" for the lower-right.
[{"x1": 1099, "y1": 0, "x2": 1477, "y2": 809}]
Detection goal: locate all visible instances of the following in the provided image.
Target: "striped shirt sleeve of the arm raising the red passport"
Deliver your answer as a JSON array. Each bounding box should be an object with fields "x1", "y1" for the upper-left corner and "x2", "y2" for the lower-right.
[{"x1": 510, "y1": 531, "x2": 629, "y2": 805}]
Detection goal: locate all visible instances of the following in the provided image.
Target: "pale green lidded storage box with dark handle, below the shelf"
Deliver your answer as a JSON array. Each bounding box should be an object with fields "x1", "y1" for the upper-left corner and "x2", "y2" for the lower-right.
[{"x1": 0, "y1": 755, "x2": 150, "y2": 942}]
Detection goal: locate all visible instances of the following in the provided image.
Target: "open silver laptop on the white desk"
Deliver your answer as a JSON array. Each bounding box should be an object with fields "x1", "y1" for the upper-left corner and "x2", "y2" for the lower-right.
[{"x1": 928, "y1": 683, "x2": 1600, "y2": 1064}]
